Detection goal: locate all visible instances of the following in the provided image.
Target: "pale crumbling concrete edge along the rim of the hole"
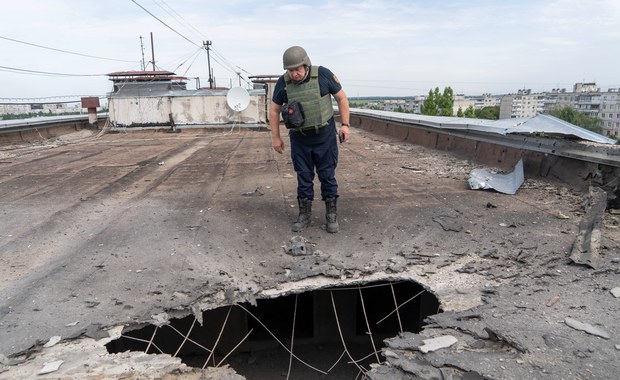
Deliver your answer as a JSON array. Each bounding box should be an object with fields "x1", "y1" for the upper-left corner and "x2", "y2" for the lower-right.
[{"x1": 0, "y1": 258, "x2": 502, "y2": 380}]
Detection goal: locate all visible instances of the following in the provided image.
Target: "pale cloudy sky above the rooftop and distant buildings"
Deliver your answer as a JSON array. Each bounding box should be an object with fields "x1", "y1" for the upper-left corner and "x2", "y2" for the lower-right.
[{"x1": 0, "y1": 0, "x2": 620, "y2": 102}]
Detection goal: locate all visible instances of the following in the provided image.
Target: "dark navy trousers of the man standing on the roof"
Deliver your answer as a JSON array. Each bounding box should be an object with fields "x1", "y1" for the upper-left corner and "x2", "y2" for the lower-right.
[{"x1": 290, "y1": 119, "x2": 338, "y2": 200}]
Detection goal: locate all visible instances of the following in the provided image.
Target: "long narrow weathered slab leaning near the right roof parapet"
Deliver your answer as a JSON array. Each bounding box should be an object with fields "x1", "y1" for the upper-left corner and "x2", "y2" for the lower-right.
[{"x1": 570, "y1": 187, "x2": 607, "y2": 269}]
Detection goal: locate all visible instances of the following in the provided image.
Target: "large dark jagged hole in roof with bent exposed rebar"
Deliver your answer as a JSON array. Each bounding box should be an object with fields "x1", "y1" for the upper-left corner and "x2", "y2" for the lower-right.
[{"x1": 107, "y1": 281, "x2": 441, "y2": 379}]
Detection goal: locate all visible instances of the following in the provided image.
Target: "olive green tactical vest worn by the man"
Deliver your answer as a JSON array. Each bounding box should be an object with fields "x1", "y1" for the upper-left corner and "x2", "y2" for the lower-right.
[{"x1": 284, "y1": 66, "x2": 334, "y2": 130}]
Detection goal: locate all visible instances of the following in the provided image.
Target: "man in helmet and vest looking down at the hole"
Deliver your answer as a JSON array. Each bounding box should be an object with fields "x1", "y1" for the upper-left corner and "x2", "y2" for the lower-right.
[{"x1": 269, "y1": 46, "x2": 349, "y2": 233}]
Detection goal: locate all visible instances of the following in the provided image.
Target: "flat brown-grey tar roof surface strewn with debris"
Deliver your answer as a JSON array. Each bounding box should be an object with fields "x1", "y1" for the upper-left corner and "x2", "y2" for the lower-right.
[{"x1": 0, "y1": 128, "x2": 620, "y2": 378}]
